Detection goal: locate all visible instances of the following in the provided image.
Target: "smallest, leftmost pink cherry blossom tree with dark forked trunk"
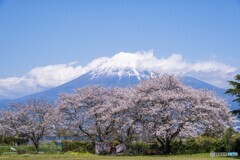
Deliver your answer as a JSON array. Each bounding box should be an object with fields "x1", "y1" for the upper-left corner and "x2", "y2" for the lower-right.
[{"x1": 0, "y1": 99, "x2": 59, "y2": 151}]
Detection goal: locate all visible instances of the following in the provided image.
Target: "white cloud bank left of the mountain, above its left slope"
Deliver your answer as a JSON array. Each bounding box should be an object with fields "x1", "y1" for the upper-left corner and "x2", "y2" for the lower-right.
[{"x1": 0, "y1": 63, "x2": 85, "y2": 98}]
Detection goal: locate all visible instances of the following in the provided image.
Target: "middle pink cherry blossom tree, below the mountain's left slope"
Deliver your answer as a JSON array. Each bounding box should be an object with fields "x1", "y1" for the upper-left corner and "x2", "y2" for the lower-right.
[{"x1": 58, "y1": 86, "x2": 124, "y2": 142}]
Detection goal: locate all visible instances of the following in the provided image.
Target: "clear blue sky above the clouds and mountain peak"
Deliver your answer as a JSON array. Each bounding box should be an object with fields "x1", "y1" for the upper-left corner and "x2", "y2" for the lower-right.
[{"x1": 0, "y1": 0, "x2": 240, "y2": 99}]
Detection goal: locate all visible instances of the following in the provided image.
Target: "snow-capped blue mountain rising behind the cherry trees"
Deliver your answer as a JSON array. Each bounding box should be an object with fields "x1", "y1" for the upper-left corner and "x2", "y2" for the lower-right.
[{"x1": 0, "y1": 53, "x2": 237, "y2": 109}]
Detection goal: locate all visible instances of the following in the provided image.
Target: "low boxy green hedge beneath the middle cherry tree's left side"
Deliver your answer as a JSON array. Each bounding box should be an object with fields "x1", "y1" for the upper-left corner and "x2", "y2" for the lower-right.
[{"x1": 62, "y1": 141, "x2": 95, "y2": 153}]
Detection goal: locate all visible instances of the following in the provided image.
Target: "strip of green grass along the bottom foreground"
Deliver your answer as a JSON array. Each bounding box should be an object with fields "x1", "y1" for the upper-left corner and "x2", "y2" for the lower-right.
[{"x1": 0, "y1": 153, "x2": 234, "y2": 160}]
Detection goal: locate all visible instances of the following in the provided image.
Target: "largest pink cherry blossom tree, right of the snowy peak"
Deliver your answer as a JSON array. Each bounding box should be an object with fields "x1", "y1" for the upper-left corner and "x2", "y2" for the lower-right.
[{"x1": 132, "y1": 75, "x2": 232, "y2": 154}]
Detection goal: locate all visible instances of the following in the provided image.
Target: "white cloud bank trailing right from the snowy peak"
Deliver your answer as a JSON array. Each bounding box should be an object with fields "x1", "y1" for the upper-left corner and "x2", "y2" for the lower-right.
[{"x1": 135, "y1": 52, "x2": 237, "y2": 74}]
